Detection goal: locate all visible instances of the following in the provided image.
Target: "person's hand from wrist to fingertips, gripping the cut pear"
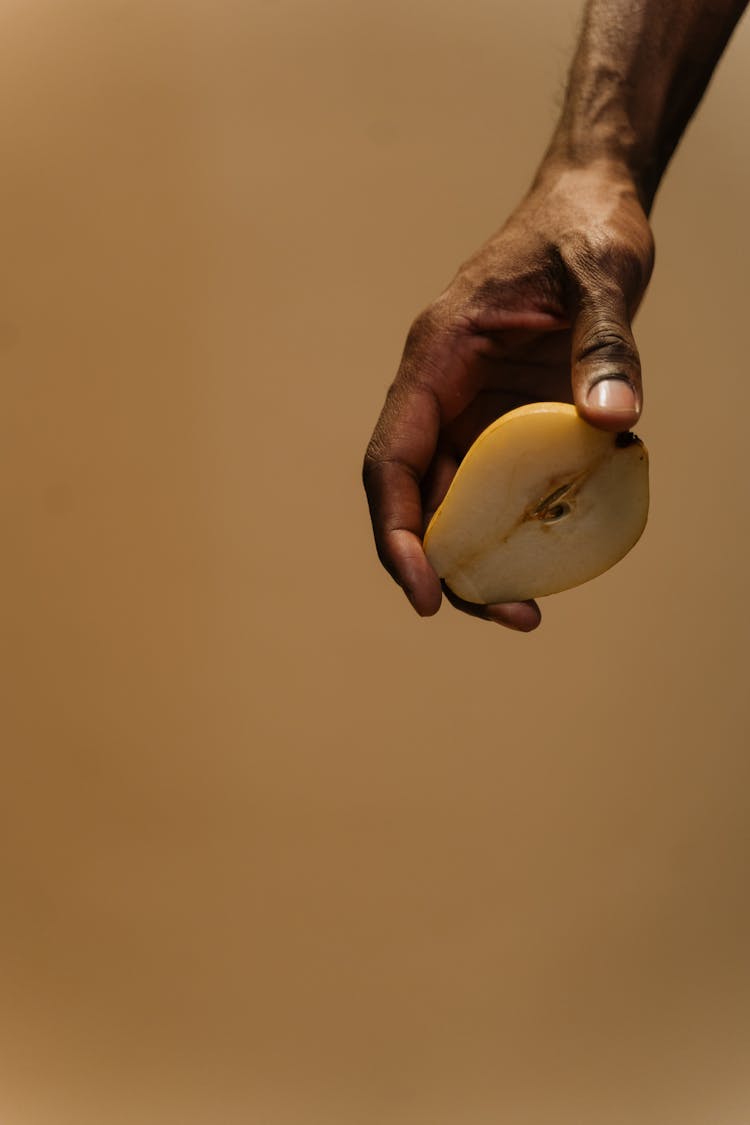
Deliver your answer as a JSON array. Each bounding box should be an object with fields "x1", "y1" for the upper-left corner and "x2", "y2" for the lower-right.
[{"x1": 363, "y1": 164, "x2": 653, "y2": 631}]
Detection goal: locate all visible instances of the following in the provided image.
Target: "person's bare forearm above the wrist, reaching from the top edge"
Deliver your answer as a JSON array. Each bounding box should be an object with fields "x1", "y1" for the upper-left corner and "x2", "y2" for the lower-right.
[{"x1": 543, "y1": 0, "x2": 748, "y2": 212}]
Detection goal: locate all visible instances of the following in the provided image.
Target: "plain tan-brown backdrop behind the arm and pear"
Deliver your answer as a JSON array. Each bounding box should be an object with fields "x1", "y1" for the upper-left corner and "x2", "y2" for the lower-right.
[{"x1": 0, "y1": 0, "x2": 750, "y2": 1125}]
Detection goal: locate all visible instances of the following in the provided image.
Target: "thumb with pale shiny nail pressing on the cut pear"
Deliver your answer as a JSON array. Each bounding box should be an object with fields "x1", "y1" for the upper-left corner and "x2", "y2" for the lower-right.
[{"x1": 571, "y1": 285, "x2": 643, "y2": 430}]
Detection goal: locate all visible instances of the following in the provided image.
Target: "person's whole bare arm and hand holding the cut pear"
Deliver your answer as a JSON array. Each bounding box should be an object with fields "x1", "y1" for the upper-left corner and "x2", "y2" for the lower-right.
[{"x1": 363, "y1": 0, "x2": 746, "y2": 632}]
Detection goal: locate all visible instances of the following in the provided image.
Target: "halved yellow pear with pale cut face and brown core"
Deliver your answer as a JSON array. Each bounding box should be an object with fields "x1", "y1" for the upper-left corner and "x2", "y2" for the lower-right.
[{"x1": 424, "y1": 403, "x2": 649, "y2": 604}]
